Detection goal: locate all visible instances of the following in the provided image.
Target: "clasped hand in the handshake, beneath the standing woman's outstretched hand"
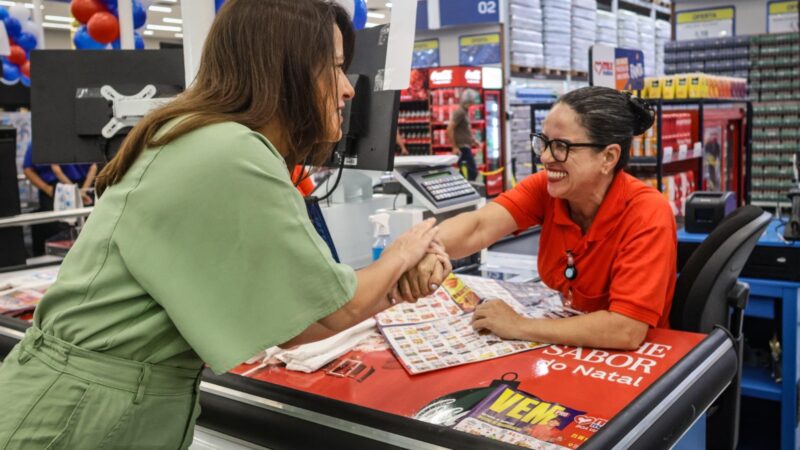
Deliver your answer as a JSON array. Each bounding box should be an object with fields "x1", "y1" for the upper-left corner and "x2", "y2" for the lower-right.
[{"x1": 397, "y1": 242, "x2": 453, "y2": 301}]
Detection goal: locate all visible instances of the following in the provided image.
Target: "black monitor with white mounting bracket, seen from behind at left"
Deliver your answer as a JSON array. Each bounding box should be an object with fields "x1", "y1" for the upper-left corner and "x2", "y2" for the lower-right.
[{"x1": 31, "y1": 50, "x2": 184, "y2": 164}]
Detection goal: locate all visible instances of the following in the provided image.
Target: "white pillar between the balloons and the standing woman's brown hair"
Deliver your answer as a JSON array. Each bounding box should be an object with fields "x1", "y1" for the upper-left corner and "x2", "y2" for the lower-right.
[{"x1": 181, "y1": 0, "x2": 216, "y2": 88}]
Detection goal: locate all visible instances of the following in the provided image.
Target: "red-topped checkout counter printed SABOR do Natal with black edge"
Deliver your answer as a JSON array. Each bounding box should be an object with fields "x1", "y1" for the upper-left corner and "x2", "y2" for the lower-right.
[{"x1": 0, "y1": 264, "x2": 737, "y2": 449}]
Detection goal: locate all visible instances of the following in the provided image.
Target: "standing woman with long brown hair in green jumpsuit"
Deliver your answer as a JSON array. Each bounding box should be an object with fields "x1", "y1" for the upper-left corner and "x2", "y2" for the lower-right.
[{"x1": 0, "y1": 0, "x2": 450, "y2": 449}]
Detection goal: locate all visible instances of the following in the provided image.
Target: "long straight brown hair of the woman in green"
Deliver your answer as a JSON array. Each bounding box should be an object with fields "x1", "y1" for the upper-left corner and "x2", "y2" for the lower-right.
[{"x1": 96, "y1": 0, "x2": 355, "y2": 194}]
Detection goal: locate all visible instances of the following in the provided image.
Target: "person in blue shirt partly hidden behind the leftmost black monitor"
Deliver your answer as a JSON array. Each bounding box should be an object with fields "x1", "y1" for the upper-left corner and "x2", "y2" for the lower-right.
[{"x1": 22, "y1": 145, "x2": 97, "y2": 256}]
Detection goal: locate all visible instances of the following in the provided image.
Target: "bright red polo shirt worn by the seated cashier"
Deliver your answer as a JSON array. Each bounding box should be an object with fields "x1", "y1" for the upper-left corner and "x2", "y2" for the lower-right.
[{"x1": 495, "y1": 172, "x2": 677, "y2": 328}]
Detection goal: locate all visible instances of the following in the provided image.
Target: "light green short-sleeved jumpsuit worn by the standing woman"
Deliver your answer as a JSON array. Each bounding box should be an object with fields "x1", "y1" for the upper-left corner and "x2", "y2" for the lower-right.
[{"x1": 0, "y1": 121, "x2": 356, "y2": 449}]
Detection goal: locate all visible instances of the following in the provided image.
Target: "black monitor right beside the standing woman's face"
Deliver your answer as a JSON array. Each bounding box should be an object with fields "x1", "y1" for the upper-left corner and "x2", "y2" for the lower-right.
[{"x1": 328, "y1": 25, "x2": 400, "y2": 171}]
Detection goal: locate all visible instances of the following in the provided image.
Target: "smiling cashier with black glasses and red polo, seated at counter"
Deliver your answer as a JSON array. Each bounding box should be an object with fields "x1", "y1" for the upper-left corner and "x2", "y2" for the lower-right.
[{"x1": 399, "y1": 87, "x2": 677, "y2": 350}]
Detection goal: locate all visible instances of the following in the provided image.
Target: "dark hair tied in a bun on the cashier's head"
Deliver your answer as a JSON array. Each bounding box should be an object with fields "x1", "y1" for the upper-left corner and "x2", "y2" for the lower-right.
[{"x1": 557, "y1": 86, "x2": 655, "y2": 171}]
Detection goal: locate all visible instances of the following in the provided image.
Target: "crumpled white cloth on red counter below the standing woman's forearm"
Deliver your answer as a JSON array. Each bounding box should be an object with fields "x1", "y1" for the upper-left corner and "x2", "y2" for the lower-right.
[{"x1": 248, "y1": 319, "x2": 377, "y2": 373}]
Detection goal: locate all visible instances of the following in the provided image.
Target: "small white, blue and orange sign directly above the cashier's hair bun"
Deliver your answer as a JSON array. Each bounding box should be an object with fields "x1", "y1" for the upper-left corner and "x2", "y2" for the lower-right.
[{"x1": 590, "y1": 45, "x2": 645, "y2": 91}]
